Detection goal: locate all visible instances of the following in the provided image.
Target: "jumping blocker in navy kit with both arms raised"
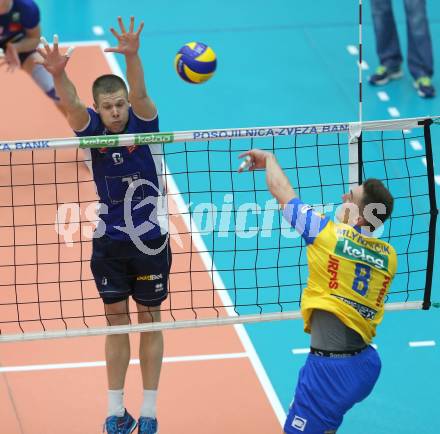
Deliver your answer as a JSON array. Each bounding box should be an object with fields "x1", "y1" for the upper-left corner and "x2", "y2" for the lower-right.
[{"x1": 39, "y1": 17, "x2": 171, "y2": 434}]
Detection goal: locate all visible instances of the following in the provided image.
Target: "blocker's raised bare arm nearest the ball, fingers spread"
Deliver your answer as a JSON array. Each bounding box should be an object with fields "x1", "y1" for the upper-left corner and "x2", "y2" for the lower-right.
[{"x1": 105, "y1": 17, "x2": 157, "y2": 120}]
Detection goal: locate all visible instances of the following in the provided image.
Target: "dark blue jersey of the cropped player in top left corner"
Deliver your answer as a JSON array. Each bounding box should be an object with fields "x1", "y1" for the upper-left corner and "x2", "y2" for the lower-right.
[{"x1": 0, "y1": 0, "x2": 40, "y2": 46}]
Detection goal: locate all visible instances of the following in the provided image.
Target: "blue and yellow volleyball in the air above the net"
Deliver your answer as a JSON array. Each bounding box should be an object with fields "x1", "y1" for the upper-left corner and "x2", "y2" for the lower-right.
[{"x1": 174, "y1": 42, "x2": 217, "y2": 84}]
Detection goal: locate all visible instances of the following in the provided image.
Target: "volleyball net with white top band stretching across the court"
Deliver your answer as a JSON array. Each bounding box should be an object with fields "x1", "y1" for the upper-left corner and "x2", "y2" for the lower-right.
[{"x1": 0, "y1": 118, "x2": 440, "y2": 342}]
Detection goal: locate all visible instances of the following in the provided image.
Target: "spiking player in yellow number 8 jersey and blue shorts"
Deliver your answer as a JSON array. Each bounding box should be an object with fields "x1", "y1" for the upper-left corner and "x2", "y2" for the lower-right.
[{"x1": 239, "y1": 149, "x2": 397, "y2": 434}]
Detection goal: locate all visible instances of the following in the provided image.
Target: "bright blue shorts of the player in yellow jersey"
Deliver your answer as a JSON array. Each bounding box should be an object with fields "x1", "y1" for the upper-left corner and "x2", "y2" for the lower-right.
[{"x1": 284, "y1": 347, "x2": 381, "y2": 434}]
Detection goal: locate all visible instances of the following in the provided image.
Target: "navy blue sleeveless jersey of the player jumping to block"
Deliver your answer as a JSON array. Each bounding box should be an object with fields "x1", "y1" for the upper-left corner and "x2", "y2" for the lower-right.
[{"x1": 75, "y1": 107, "x2": 168, "y2": 240}]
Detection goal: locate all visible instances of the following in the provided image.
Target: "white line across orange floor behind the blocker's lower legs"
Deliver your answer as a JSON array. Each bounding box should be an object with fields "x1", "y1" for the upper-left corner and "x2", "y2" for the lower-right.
[{"x1": 0, "y1": 353, "x2": 248, "y2": 373}]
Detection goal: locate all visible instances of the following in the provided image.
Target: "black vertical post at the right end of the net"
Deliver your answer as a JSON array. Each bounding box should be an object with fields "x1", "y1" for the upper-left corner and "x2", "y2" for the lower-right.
[{"x1": 423, "y1": 119, "x2": 438, "y2": 310}]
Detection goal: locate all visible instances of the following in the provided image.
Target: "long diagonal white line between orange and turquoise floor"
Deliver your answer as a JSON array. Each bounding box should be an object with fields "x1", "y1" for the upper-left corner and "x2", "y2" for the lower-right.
[{"x1": 95, "y1": 41, "x2": 286, "y2": 426}]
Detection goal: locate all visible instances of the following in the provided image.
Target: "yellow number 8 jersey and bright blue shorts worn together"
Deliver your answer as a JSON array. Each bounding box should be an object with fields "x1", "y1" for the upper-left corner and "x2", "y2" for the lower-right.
[{"x1": 284, "y1": 198, "x2": 397, "y2": 434}]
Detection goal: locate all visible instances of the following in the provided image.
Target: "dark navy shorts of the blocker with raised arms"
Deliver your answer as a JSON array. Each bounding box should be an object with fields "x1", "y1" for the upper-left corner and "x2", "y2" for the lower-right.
[{"x1": 90, "y1": 235, "x2": 171, "y2": 306}]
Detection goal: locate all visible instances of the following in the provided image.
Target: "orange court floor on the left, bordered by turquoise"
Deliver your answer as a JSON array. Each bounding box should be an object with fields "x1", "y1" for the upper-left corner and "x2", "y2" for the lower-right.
[{"x1": 0, "y1": 45, "x2": 282, "y2": 434}]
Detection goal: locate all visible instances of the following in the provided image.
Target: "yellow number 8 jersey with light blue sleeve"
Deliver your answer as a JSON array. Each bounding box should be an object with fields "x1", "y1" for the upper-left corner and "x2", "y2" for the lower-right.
[{"x1": 284, "y1": 198, "x2": 397, "y2": 344}]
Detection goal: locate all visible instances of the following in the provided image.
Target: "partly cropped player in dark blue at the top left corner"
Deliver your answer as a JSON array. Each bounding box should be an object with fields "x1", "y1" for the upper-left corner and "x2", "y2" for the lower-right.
[{"x1": 0, "y1": 0, "x2": 64, "y2": 113}]
